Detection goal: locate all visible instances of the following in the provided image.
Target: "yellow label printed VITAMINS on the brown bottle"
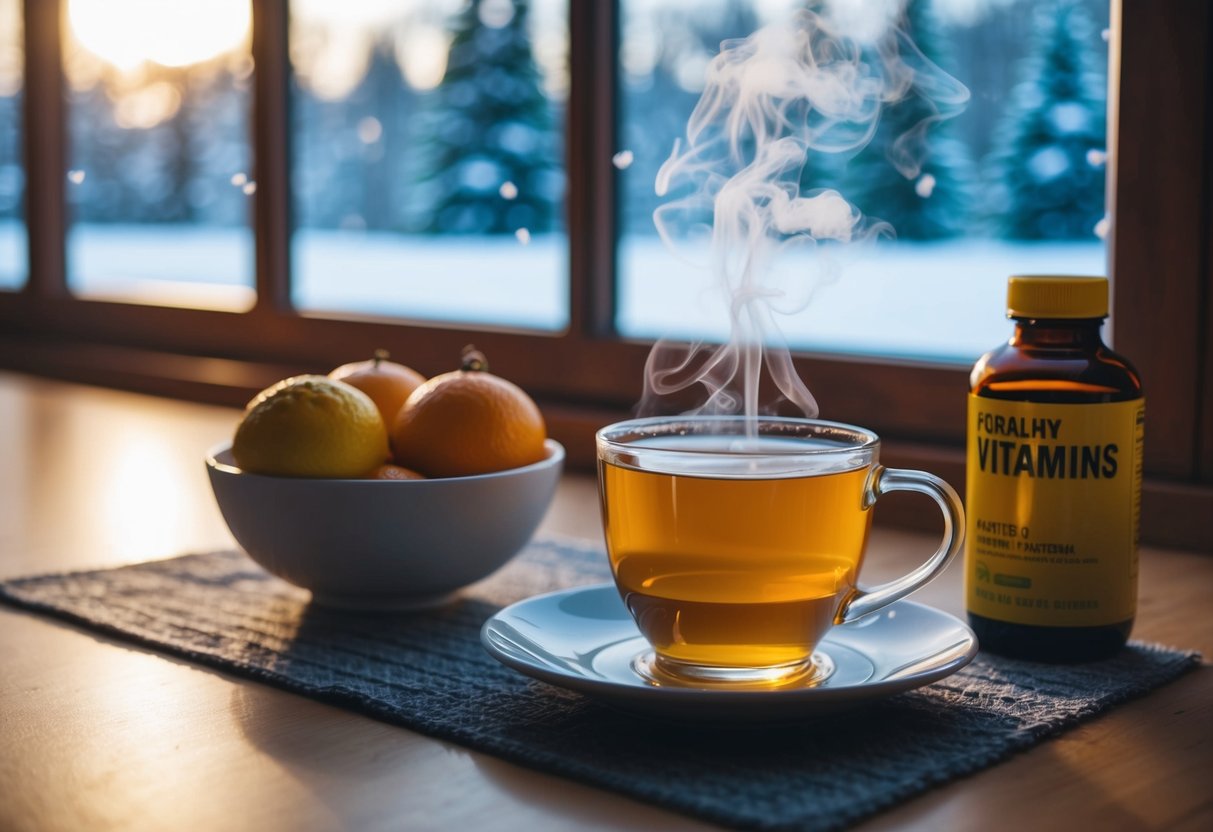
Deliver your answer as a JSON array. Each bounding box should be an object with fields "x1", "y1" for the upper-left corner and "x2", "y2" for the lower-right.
[{"x1": 964, "y1": 394, "x2": 1145, "y2": 627}]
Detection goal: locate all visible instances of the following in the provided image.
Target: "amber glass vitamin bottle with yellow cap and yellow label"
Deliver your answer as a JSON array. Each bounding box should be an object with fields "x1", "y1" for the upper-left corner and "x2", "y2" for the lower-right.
[{"x1": 964, "y1": 277, "x2": 1145, "y2": 661}]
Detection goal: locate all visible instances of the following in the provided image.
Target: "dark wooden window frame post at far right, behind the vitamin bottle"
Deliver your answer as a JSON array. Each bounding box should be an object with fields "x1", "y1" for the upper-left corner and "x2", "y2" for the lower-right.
[{"x1": 1110, "y1": 0, "x2": 1213, "y2": 480}]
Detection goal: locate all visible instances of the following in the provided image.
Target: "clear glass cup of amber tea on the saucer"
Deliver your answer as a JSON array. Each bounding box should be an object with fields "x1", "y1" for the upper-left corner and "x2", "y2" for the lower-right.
[{"x1": 599, "y1": 417, "x2": 959, "y2": 682}]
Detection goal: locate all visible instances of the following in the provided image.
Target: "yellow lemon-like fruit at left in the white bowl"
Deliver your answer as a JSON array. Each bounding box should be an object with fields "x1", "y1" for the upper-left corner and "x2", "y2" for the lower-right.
[{"x1": 232, "y1": 375, "x2": 391, "y2": 477}]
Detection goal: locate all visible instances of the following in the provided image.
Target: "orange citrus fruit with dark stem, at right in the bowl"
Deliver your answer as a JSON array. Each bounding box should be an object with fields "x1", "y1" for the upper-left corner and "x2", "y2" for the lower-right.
[{"x1": 392, "y1": 349, "x2": 546, "y2": 477}]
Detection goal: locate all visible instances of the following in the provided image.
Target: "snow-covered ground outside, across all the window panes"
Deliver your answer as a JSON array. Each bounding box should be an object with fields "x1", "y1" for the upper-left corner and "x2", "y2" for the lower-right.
[{"x1": 0, "y1": 223, "x2": 1105, "y2": 364}]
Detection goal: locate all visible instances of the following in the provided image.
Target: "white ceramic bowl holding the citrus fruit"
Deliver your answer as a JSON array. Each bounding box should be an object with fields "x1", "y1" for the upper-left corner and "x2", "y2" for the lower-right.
[{"x1": 206, "y1": 439, "x2": 564, "y2": 610}]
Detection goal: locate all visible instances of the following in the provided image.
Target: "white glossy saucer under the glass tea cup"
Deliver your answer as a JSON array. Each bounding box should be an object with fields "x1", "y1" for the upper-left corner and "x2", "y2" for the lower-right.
[{"x1": 480, "y1": 583, "x2": 978, "y2": 722}]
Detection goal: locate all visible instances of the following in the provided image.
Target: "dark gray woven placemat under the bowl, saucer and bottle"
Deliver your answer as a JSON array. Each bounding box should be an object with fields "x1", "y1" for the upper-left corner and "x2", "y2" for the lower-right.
[{"x1": 0, "y1": 541, "x2": 1200, "y2": 830}]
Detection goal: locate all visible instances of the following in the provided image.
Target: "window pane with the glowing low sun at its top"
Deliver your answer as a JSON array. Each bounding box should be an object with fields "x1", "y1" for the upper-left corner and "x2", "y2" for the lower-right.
[{"x1": 62, "y1": 0, "x2": 256, "y2": 310}]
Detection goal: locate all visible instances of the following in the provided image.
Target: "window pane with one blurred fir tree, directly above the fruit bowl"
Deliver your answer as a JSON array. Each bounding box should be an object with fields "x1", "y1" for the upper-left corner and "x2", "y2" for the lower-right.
[{"x1": 290, "y1": 0, "x2": 569, "y2": 331}]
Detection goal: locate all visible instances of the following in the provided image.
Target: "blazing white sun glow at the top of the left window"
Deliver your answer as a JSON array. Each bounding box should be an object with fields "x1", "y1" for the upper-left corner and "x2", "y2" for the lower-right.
[{"x1": 68, "y1": 0, "x2": 252, "y2": 70}]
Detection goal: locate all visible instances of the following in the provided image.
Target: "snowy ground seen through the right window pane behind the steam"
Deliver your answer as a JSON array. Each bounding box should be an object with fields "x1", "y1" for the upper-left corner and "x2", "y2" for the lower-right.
[{"x1": 619, "y1": 239, "x2": 1106, "y2": 364}]
